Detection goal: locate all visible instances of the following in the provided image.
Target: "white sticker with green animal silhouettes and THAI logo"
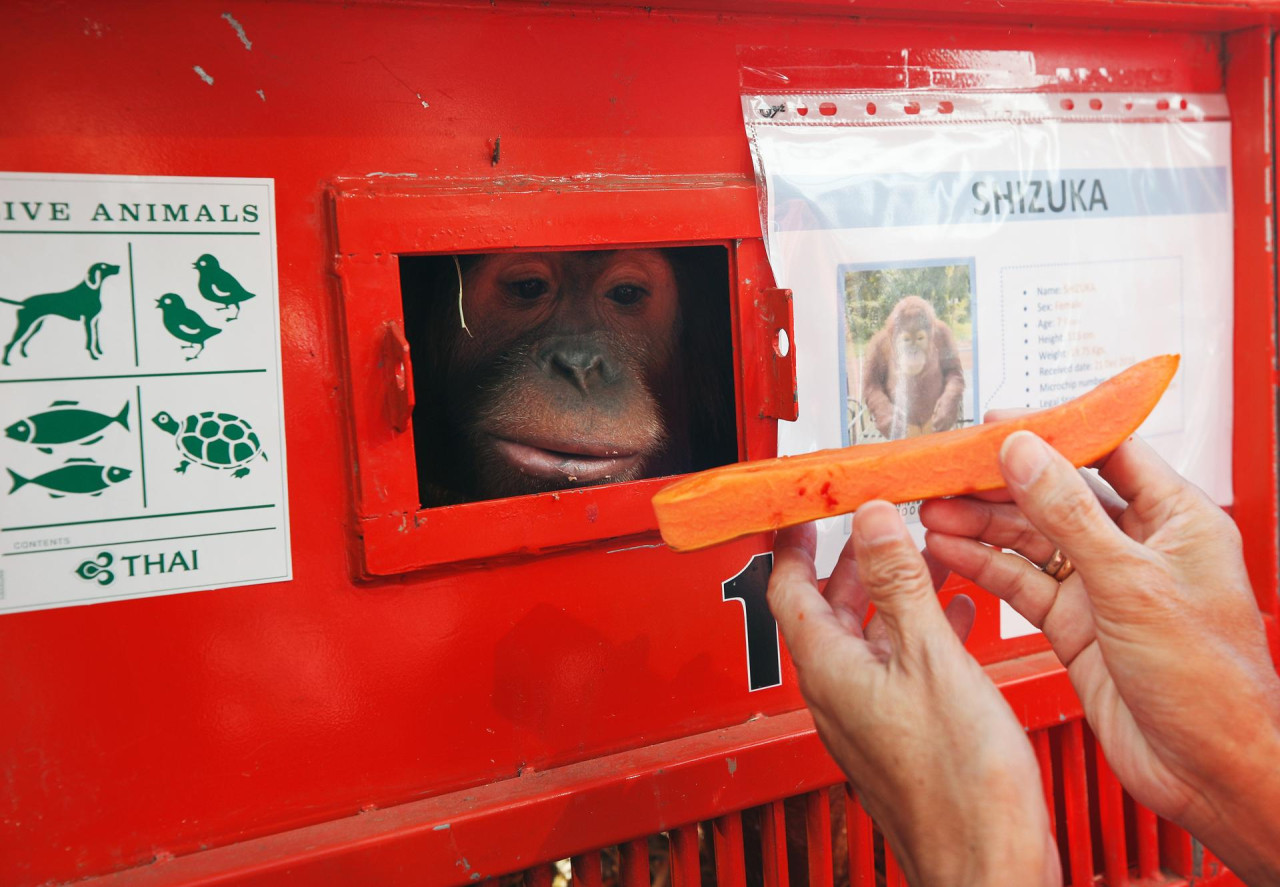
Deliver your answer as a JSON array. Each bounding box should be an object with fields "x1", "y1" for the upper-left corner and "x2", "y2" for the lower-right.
[{"x1": 0, "y1": 173, "x2": 292, "y2": 613}]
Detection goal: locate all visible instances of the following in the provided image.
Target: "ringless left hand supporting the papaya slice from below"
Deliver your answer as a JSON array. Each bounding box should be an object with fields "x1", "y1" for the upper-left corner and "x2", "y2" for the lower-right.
[{"x1": 769, "y1": 502, "x2": 1062, "y2": 887}]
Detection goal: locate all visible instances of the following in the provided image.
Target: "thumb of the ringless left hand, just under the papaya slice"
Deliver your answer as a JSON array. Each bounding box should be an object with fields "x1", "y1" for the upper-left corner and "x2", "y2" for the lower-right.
[{"x1": 852, "y1": 502, "x2": 952, "y2": 651}]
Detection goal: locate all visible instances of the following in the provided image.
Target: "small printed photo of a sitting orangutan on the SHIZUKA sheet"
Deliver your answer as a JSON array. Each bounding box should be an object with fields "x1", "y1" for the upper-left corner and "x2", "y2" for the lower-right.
[{"x1": 845, "y1": 265, "x2": 973, "y2": 443}]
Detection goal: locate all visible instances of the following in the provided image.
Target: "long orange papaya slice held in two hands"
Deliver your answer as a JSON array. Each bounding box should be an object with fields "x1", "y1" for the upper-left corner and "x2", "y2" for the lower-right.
[{"x1": 653, "y1": 355, "x2": 1179, "y2": 552}]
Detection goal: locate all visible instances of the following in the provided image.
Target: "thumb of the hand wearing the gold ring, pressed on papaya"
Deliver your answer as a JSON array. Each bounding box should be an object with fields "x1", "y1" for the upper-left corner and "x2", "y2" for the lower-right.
[{"x1": 1000, "y1": 431, "x2": 1137, "y2": 575}]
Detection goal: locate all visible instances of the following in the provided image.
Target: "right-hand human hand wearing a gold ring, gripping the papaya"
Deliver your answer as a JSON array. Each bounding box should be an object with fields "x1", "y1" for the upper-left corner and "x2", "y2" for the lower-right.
[{"x1": 920, "y1": 431, "x2": 1280, "y2": 883}]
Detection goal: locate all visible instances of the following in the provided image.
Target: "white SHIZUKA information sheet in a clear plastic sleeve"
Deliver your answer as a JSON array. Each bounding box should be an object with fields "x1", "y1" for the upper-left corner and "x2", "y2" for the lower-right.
[{"x1": 744, "y1": 96, "x2": 1233, "y2": 634}]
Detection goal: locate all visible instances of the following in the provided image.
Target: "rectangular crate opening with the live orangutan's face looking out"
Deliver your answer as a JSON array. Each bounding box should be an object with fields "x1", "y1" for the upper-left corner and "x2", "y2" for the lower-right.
[{"x1": 401, "y1": 247, "x2": 737, "y2": 507}]
